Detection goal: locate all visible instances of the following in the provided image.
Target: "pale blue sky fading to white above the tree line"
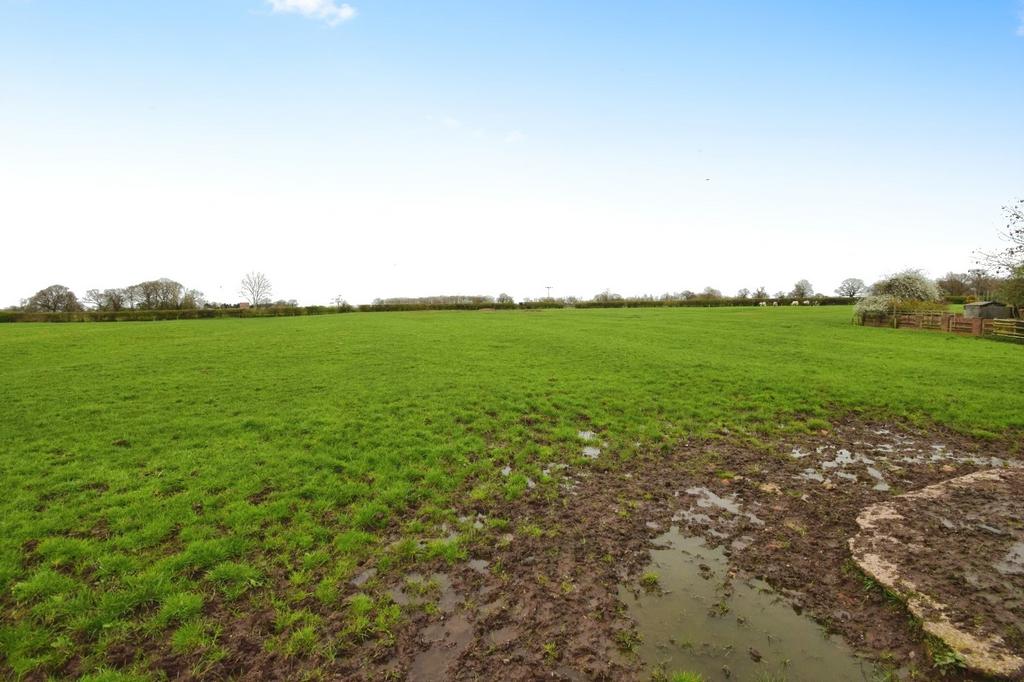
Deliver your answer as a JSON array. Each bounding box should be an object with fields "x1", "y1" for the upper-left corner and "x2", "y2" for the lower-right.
[{"x1": 0, "y1": 0, "x2": 1024, "y2": 305}]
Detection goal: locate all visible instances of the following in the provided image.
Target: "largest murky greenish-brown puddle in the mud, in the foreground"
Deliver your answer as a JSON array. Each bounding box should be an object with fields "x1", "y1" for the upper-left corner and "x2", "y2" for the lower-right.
[{"x1": 618, "y1": 527, "x2": 871, "y2": 682}]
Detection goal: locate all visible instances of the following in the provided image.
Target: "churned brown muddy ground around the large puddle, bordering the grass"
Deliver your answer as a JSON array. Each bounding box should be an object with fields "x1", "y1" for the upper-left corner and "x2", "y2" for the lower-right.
[{"x1": 193, "y1": 422, "x2": 1021, "y2": 680}]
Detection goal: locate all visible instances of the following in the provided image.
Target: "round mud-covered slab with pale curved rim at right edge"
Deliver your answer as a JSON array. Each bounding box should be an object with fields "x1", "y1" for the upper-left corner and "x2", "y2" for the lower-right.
[{"x1": 850, "y1": 468, "x2": 1024, "y2": 679}]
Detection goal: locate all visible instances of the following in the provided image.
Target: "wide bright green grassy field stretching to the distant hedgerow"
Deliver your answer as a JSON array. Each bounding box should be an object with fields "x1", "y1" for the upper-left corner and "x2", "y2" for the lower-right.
[{"x1": 0, "y1": 307, "x2": 1024, "y2": 677}]
